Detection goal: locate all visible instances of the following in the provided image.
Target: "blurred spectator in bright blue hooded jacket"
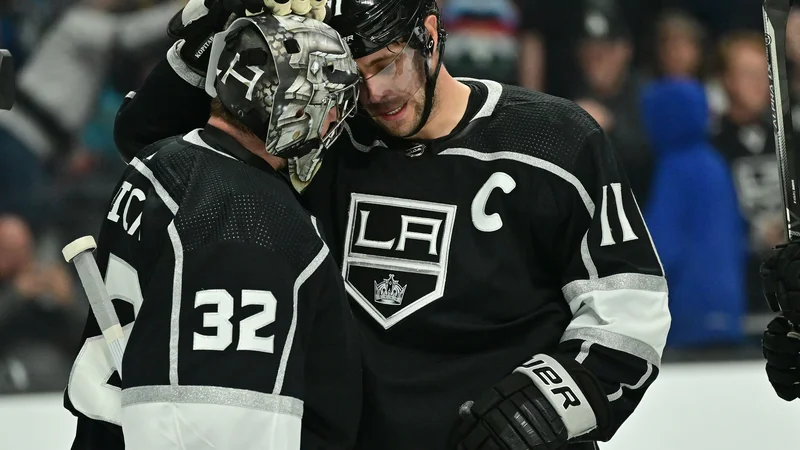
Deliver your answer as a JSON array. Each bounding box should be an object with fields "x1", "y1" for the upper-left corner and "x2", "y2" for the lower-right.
[{"x1": 641, "y1": 79, "x2": 747, "y2": 348}]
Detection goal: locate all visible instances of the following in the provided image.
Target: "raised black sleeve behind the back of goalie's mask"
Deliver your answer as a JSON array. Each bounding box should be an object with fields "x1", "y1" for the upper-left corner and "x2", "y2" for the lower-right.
[{"x1": 114, "y1": 50, "x2": 211, "y2": 162}]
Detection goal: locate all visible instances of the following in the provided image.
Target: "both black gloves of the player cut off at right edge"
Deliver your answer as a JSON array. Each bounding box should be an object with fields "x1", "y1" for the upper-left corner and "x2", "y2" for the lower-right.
[{"x1": 761, "y1": 241, "x2": 800, "y2": 401}]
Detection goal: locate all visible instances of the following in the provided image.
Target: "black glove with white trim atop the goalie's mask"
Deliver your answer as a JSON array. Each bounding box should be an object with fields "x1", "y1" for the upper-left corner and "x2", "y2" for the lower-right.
[{"x1": 167, "y1": 0, "x2": 264, "y2": 76}]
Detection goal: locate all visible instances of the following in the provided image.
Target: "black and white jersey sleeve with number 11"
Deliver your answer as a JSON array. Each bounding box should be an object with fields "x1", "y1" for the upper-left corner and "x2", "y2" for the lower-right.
[{"x1": 559, "y1": 125, "x2": 670, "y2": 440}]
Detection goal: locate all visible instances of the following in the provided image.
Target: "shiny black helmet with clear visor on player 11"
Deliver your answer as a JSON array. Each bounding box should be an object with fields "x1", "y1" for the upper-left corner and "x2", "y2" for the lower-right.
[{"x1": 329, "y1": 0, "x2": 447, "y2": 137}]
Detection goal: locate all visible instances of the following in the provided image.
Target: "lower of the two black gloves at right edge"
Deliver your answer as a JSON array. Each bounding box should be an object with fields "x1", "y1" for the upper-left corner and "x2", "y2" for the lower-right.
[{"x1": 762, "y1": 316, "x2": 800, "y2": 401}]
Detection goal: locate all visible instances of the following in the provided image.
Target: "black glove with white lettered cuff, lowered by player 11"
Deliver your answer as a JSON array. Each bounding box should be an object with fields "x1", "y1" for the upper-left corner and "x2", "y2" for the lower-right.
[{"x1": 448, "y1": 355, "x2": 610, "y2": 450}]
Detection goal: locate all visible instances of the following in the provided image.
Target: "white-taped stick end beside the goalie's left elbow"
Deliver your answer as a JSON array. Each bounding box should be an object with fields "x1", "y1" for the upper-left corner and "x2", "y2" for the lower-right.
[{"x1": 61, "y1": 236, "x2": 125, "y2": 378}]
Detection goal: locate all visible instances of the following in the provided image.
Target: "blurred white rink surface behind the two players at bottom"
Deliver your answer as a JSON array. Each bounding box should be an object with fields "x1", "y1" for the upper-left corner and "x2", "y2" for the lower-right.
[{"x1": 0, "y1": 361, "x2": 800, "y2": 450}]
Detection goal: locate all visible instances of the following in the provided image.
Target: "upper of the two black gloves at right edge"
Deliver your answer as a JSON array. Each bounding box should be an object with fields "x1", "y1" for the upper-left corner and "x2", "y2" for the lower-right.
[{"x1": 761, "y1": 242, "x2": 800, "y2": 325}]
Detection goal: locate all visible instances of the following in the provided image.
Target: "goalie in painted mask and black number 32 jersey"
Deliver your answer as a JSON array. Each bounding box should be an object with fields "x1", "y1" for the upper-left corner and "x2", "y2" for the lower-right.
[{"x1": 65, "y1": 7, "x2": 361, "y2": 450}]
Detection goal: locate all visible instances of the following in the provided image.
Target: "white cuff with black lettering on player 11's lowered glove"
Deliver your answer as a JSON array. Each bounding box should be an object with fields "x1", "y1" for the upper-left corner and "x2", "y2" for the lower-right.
[{"x1": 514, "y1": 354, "x2": 609, "y2": 439}]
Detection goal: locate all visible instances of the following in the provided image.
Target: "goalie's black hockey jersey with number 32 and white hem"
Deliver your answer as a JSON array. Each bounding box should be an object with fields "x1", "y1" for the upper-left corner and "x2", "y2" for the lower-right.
[{"x1": 65, "y1": 127, "x2": 361, "y2": 450}]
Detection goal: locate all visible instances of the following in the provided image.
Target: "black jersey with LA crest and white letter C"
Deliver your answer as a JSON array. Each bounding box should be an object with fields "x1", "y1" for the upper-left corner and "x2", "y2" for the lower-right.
[{"x1": 304, "y1": 80, "x2": 670, "y2": 450}]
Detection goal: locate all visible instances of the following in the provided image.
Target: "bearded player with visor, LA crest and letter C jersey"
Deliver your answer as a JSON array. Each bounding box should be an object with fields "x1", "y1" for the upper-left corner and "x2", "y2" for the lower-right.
[{"x1": 116, "y1": 0, "x2": 670, "y2": 450}]
